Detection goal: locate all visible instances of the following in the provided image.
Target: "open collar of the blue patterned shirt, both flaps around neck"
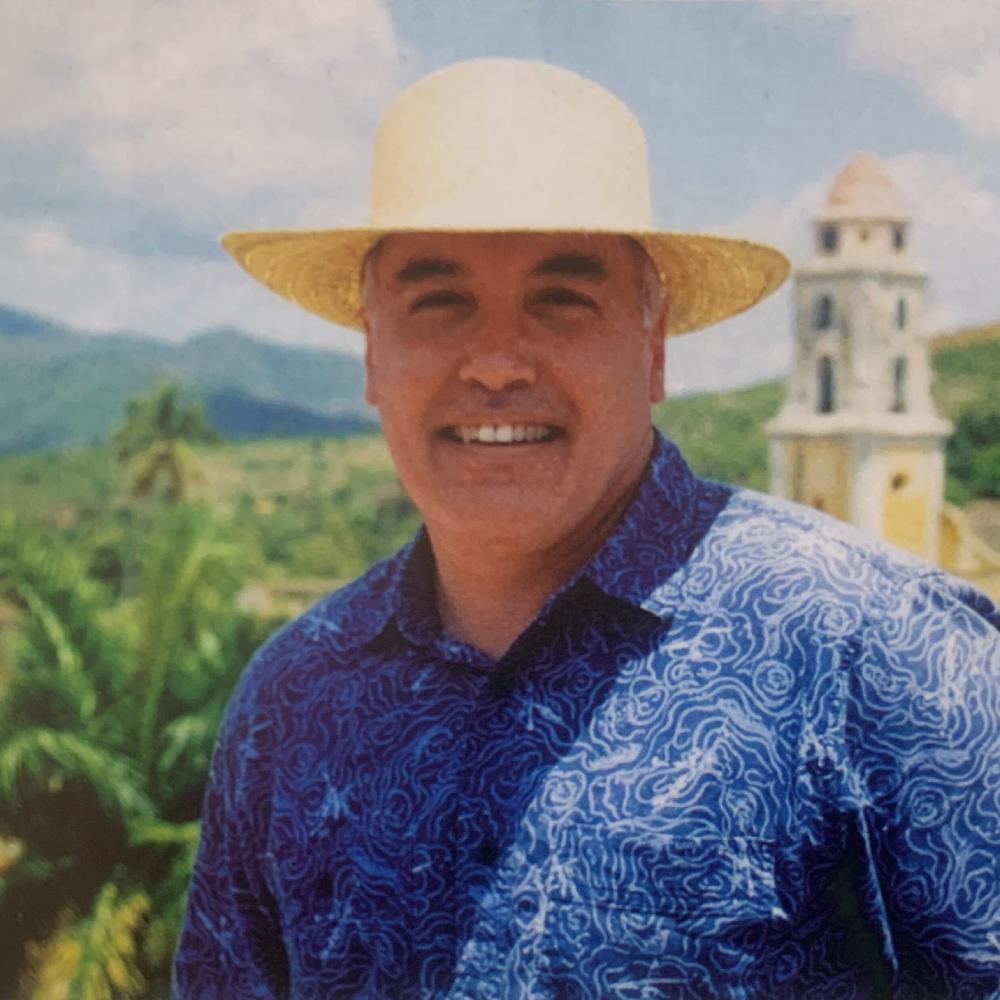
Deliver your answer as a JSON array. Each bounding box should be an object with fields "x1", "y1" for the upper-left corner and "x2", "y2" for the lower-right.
[{"x1": 323, "y1": 431, "x2": 732, "y2": 646}]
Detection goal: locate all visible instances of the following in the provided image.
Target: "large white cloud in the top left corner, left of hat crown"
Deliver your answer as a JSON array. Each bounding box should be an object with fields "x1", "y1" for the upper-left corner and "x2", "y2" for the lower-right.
[{"x1": 0, "y1": 0, "x2": 399, "y2": 228}]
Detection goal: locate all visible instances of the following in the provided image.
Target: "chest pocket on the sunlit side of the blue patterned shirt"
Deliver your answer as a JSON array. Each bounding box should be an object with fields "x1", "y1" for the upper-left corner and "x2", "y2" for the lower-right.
[{"x1": 533, "y1": 825, "x2": 786, "y2": 998}]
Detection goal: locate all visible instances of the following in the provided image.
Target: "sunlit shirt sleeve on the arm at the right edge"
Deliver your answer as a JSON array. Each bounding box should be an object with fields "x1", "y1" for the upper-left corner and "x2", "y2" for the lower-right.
[{"x1": 848, "y1": 572, "x2": 1000, "y2": 998}]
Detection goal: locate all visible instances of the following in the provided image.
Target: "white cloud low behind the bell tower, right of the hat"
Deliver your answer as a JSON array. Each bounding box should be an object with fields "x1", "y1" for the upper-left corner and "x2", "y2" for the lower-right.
[{"x1": 668, "y1": 153, "x2": 1000, "y2": 393}]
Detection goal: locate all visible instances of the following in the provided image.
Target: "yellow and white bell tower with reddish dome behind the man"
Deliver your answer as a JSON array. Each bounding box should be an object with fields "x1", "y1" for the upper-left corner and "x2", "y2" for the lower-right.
[{"x1": 767, "y1": 154, "x2": 951, "y2": 562}]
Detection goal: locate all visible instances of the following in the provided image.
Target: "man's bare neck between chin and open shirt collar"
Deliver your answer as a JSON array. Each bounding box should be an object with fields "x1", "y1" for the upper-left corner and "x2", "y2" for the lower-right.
[{"x1": 428, "y1": 444, "x2": 642, "y2": 660}]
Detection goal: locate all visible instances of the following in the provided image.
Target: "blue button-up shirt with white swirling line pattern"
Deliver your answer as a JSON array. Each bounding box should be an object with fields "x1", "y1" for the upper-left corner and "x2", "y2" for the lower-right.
[{"x1": 174, "y1": 438, "x2": 1000, "y2": 1000}]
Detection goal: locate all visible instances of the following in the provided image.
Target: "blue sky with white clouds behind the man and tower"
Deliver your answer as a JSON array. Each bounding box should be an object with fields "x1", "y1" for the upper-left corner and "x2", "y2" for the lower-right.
[{"x1": 0, "y1": 0, "x2": 1000, "y2": 393}]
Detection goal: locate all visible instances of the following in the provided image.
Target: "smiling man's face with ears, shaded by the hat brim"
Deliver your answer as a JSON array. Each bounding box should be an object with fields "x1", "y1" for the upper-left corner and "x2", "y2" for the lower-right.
[{"x1": 365, "y1": 233, "x2": 663, "y2": 552}]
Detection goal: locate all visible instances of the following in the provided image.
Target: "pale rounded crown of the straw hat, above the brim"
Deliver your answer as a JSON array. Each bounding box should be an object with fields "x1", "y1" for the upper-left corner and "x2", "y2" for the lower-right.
[{"x1": 369, "y1": 59, "x2": 652, "y2": 232}]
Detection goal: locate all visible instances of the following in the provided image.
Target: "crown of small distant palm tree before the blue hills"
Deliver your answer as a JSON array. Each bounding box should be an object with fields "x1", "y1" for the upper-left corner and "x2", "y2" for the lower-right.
[{"x1": 114, "y1": 382, "x2": 219, "y2": 503}]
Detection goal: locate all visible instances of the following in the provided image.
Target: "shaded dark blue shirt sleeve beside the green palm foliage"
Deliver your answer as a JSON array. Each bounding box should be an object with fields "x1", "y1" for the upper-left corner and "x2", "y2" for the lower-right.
[{"x1": 171, "y1": 671, "x2": 288, "y2": 1000}]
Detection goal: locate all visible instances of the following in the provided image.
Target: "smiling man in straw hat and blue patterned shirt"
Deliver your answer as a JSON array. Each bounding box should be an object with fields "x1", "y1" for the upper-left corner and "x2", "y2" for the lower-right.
[{"x1": 175, "y1": 60, "x2": 1000, "y2": 998}]
